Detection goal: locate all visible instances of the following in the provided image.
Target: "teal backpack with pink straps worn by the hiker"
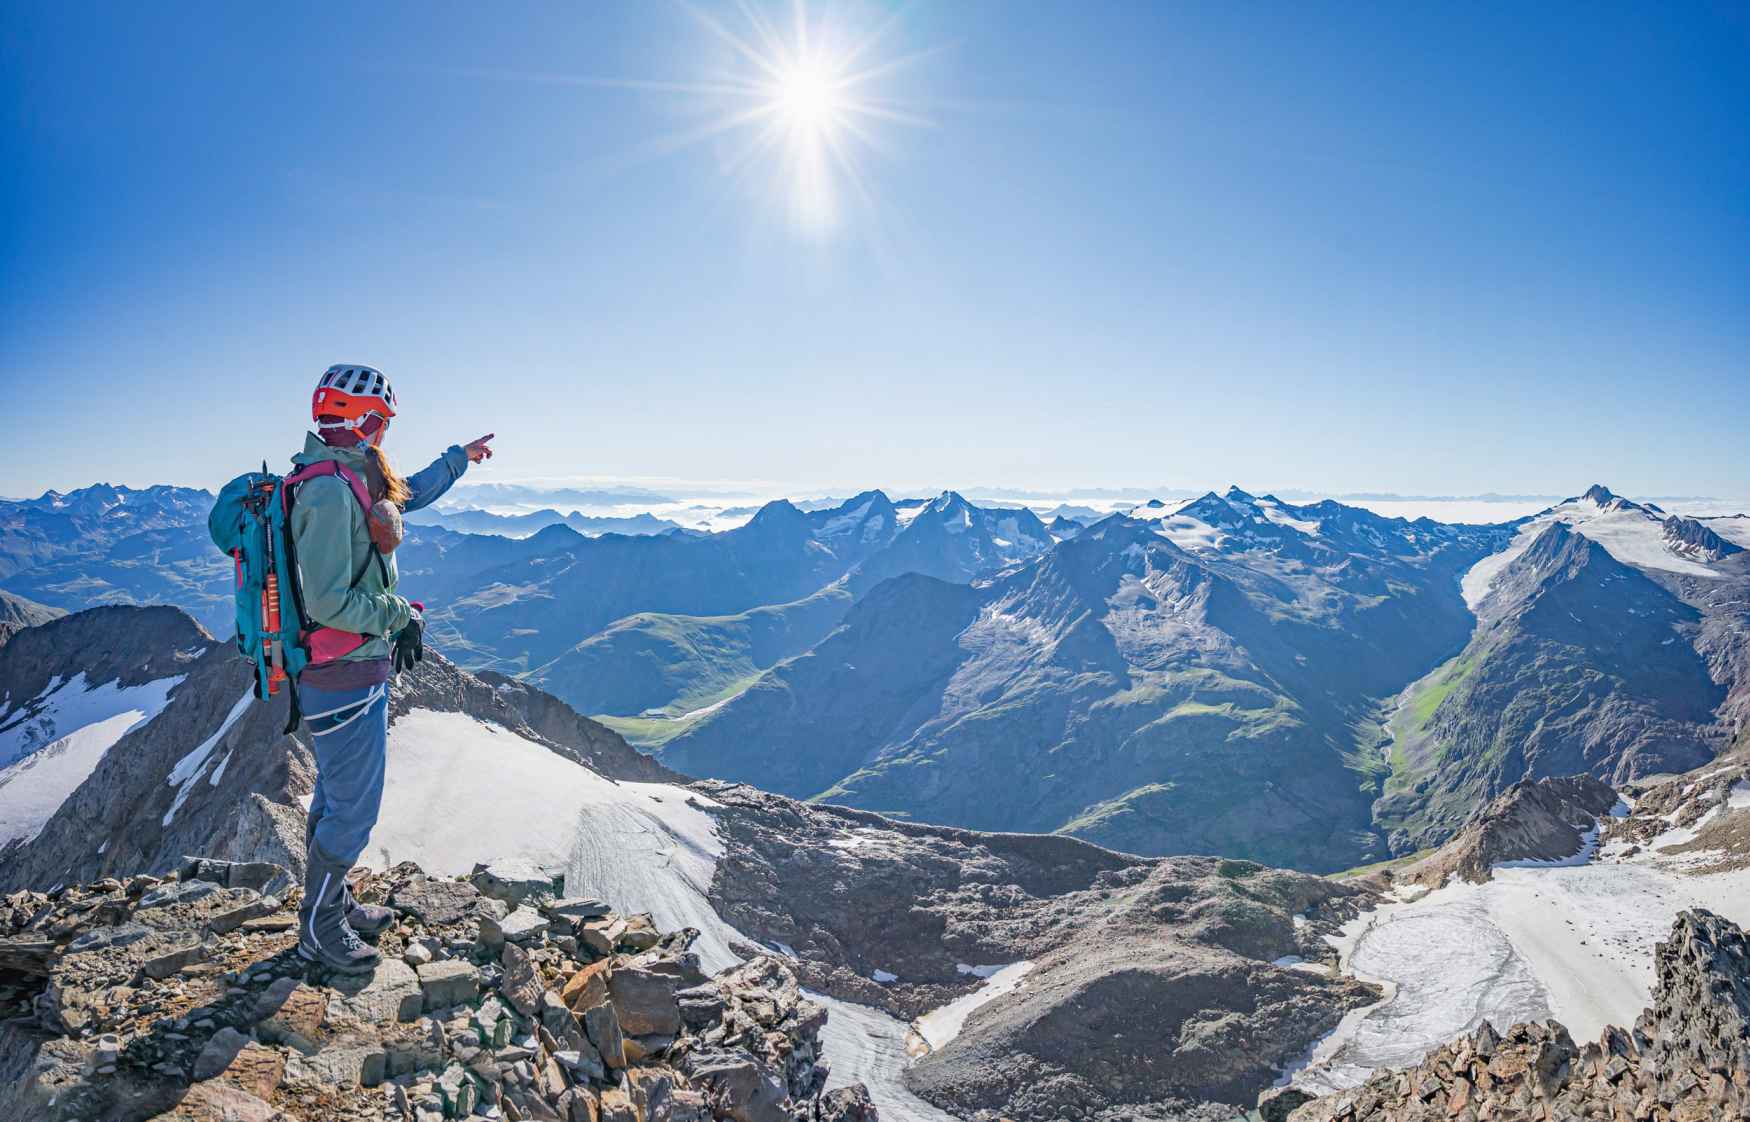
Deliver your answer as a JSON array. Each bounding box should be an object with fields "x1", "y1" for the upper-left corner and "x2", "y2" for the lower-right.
[{"x1": 207, "y1": 460, "x2": 375, "y2": 733}]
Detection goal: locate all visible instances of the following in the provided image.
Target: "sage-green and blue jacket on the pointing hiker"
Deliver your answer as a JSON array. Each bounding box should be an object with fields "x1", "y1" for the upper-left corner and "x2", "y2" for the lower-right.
[{"x1": 292, "y1": 432, "x2": 467, "y2": 662}]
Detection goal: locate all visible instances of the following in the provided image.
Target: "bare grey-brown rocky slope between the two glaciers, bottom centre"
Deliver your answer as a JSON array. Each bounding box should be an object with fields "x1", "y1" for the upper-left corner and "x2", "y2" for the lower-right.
[{"x1": 698, "y1": 784, "x2": 1377, "y2": 1122}]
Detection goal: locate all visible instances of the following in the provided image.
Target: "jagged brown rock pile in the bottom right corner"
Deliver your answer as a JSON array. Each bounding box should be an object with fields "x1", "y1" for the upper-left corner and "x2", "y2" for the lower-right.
[{"x1": 1288, "y1": 908, "x2": 1750, "y2": 1122}]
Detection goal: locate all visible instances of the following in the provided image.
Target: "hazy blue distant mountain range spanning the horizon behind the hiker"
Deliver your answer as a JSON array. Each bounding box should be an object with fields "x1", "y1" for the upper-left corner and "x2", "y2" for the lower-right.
[{"x1": 0, "y1": 487, "x2": 1750, "y2": 870}]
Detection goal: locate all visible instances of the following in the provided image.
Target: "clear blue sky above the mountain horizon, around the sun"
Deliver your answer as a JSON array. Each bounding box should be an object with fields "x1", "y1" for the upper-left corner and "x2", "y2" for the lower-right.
[{"x1": 0, "y1": 0, "x2": 1750, "y2": 495}]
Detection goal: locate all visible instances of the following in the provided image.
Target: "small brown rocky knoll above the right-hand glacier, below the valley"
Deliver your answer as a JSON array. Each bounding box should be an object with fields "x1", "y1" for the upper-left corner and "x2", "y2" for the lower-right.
[{"x1": 1393, "y1": 775, "x2": 1619, "y2": 887}]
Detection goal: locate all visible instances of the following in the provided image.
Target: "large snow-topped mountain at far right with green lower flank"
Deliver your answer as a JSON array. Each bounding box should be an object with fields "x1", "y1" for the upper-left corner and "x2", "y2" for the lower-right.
[{"x1": 1374, "y1": 487, "x2": 1750, "y2": 854}]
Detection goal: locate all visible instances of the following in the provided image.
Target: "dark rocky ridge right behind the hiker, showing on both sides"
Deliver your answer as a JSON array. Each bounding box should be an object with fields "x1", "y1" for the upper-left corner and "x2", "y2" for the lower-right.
[{"x1": 0, "y1": 607, "x2": 679, "y2": 891}]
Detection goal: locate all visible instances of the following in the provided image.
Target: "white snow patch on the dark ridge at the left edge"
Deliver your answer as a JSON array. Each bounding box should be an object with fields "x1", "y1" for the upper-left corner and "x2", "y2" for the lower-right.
[{"x1": 0, "y1": 674, "x2": 182, "y2": 845}]
